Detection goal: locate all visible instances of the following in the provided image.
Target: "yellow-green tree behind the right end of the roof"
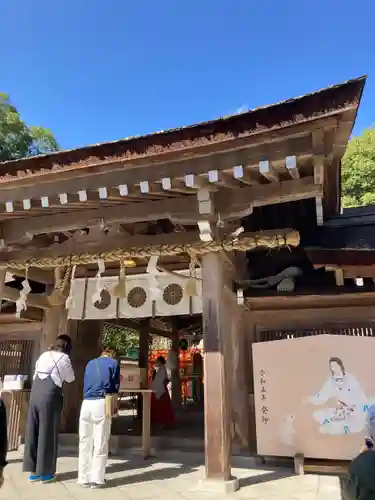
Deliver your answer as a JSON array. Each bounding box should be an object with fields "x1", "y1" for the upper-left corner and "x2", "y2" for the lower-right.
[{"x1": 341, "y1": 127, "x2": 375, "y2": 208}]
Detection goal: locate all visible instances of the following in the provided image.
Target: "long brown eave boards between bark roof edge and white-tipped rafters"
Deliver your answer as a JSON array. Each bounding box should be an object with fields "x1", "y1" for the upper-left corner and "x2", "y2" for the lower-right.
[{"x1": 0, "y1": 114, "x2": 339, "y2": 204}]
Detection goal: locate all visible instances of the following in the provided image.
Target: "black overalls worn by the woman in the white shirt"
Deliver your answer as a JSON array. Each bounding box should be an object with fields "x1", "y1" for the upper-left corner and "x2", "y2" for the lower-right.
[{"x1": 23, "y1": 376, "x2": 62, "y2": 476}]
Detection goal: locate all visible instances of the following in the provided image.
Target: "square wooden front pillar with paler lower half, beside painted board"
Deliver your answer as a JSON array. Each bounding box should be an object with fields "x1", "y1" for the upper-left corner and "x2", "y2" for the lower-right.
[{"x1": 202, "y1": 252, "x2": 236, "y2": 489}]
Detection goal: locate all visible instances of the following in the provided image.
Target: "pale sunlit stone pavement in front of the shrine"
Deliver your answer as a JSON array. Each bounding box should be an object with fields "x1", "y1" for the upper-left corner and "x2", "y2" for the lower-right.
[{"x1": 0, "y1": 451, "x2": 341, "y2": 500}]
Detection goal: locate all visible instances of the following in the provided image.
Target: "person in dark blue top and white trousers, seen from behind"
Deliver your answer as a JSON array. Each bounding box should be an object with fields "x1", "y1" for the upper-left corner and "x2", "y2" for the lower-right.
[{"x1": 78, "y1": 349, "x2": 120, "y2": 488}]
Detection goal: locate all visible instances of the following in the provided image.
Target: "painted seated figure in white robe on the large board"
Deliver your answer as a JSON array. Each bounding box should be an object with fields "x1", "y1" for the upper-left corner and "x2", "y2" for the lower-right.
[{"x1": 307, "y1": 357, "x2": 373, "y2": 435}]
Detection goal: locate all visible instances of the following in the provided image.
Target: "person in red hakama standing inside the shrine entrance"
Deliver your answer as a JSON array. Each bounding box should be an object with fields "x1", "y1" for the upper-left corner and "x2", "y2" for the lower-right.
[{"x1": 151, "y1": 356, "x2": 175, "y2": 427}]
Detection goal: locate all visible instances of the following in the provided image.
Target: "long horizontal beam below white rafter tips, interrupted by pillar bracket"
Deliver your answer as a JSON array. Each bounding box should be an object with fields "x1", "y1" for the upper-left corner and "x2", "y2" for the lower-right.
[{"x1": 1, "y1": 177, "x2": 322, "y2": 243}]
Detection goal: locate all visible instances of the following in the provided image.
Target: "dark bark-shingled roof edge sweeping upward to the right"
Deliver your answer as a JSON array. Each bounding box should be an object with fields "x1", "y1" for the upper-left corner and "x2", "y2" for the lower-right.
[{"x1": 0, "y1": 76, "x2": 366, "y2": 177}]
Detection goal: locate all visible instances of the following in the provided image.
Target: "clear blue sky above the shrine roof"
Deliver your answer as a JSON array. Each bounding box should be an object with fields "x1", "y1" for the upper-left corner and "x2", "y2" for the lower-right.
[{"x1": 0, "y1": 0, "x2": 375, "y2": 148}]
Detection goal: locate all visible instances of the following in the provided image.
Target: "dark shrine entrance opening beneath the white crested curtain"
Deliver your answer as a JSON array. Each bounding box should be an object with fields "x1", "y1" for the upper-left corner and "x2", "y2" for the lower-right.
[{"x1": 104, "y1": 315, "x2": 204, "y2": 451}]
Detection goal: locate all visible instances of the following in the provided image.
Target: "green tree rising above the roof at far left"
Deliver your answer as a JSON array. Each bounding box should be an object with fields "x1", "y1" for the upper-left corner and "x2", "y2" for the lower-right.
[{"x1": 0, "y1": 92, "x2": 58, "y2": 162}]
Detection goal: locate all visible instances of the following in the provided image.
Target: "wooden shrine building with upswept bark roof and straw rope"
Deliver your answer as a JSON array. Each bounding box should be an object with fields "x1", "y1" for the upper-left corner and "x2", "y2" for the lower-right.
[{"x1": 0, "y1": 78, "x2": 375, "y2": 490}]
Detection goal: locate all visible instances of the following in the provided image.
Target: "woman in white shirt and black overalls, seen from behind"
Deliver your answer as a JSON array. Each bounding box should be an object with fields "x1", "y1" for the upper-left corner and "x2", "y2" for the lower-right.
[{"x1": 23, "y1": 335, "x2": 74, "y2": 484}]
